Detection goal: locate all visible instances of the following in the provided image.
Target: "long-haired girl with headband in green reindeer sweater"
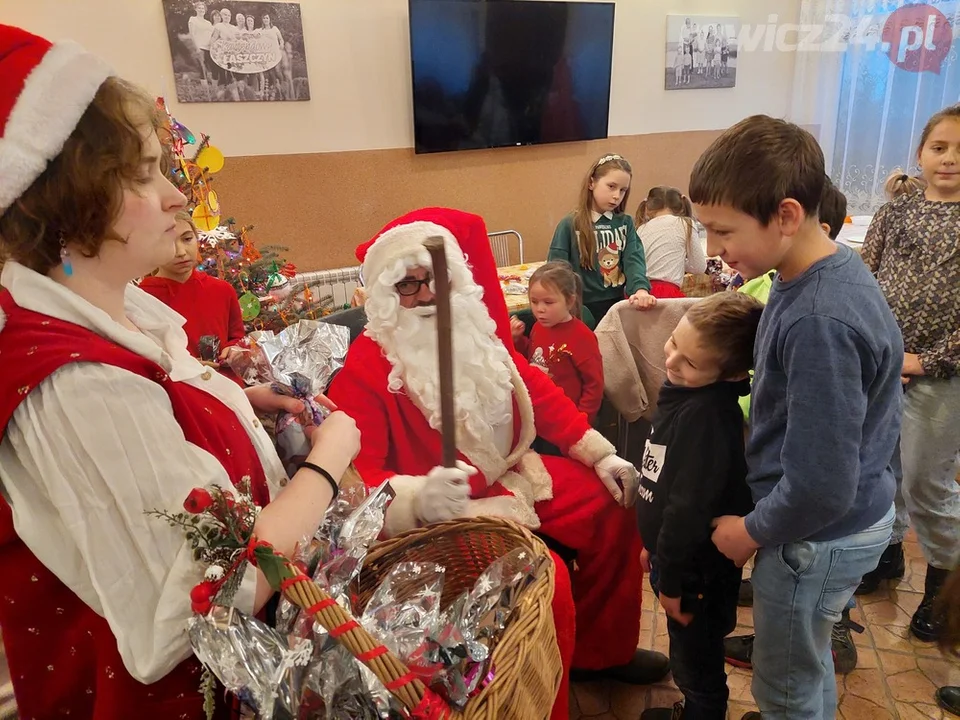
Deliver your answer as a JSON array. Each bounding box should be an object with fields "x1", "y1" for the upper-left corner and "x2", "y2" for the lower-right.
[{"x1": 547, "y1": 155, "x2": 657, "y2": 323}]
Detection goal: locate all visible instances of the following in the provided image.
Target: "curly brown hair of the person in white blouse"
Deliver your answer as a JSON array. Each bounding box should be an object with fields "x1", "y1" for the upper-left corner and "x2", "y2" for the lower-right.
[{"x1": 0, "y1": 77, "x2": 169, "y2": 274}]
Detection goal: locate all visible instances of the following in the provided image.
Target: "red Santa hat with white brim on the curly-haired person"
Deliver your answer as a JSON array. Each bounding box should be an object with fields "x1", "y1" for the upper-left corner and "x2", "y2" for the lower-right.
[{"x1": 0, "y1": 25, "x2": 113, "y2": 214}]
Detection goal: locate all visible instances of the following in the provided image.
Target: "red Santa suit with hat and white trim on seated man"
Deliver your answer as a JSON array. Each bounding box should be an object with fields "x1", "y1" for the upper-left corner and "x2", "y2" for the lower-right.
[{"x1": 329, "y1": 209, "x2": 642, "y2": 669}]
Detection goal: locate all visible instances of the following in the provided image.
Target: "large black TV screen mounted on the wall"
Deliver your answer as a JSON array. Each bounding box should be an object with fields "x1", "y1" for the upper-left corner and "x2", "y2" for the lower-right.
[{"x1": 410, "y1": 0, "x2": 614, "y2": 153}]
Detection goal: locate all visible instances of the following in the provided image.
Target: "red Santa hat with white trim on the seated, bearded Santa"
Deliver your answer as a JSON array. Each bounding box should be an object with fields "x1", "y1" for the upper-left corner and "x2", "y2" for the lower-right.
[{"x1": 357, "y1": 208, "x2": 513, "y2": 348}]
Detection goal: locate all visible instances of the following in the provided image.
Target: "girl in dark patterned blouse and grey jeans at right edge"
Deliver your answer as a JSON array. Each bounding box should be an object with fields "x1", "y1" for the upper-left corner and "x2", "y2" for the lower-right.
[{"x1": 858, "y1": 104, "x2": 960, "y2": 642}]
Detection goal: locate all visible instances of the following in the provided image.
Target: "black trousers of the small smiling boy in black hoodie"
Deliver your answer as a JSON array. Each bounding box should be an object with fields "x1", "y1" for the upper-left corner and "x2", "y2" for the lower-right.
[{"x1": 650, "y1": 560, "x2": 743, "y2": 720}]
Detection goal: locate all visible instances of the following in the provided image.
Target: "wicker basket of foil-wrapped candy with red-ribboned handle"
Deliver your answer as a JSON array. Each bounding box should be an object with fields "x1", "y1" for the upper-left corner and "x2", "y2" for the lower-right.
[{"x1": 157, "y1": 476, "x2": 561, "y2": 720}]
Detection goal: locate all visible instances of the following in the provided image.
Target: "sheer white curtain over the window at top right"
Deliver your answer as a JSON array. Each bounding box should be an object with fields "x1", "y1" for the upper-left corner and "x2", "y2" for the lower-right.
[{"x1": 790, "y1": 0, "x2": 960, "y2": 214}]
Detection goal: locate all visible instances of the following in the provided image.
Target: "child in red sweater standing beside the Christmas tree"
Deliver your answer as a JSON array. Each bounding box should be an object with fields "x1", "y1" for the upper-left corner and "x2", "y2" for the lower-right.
[{"x1": 140, "y1": 212, "x2": 246, "y2": 367}]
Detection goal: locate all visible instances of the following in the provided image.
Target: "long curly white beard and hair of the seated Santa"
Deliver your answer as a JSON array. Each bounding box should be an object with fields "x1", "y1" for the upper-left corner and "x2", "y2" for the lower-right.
[{"x1": 364, "y1": 251, "x2": 513, "y2": 445}]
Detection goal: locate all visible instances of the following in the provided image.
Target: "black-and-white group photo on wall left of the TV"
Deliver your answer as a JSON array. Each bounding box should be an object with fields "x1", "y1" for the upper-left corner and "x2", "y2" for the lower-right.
[{"x1": 161, "y1": 0, "x2": 310, "y2": 103}]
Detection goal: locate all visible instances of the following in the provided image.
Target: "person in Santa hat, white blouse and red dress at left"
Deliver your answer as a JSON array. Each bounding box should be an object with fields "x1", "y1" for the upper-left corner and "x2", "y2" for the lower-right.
[{"x1": 0, "y1": 25, "x2": 360, "y2": 720}]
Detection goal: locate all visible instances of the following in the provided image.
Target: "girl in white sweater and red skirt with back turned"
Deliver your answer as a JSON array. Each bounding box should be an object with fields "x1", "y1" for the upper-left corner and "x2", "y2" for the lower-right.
[{"x1": 637, "y1": 185, "x2": 707, "y2": 299}]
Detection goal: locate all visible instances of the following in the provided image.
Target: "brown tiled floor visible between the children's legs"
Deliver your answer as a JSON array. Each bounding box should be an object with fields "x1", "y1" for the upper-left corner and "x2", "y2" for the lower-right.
[{"x1": 570, "y1": 538, "x2": 960, "y2": 720}]
